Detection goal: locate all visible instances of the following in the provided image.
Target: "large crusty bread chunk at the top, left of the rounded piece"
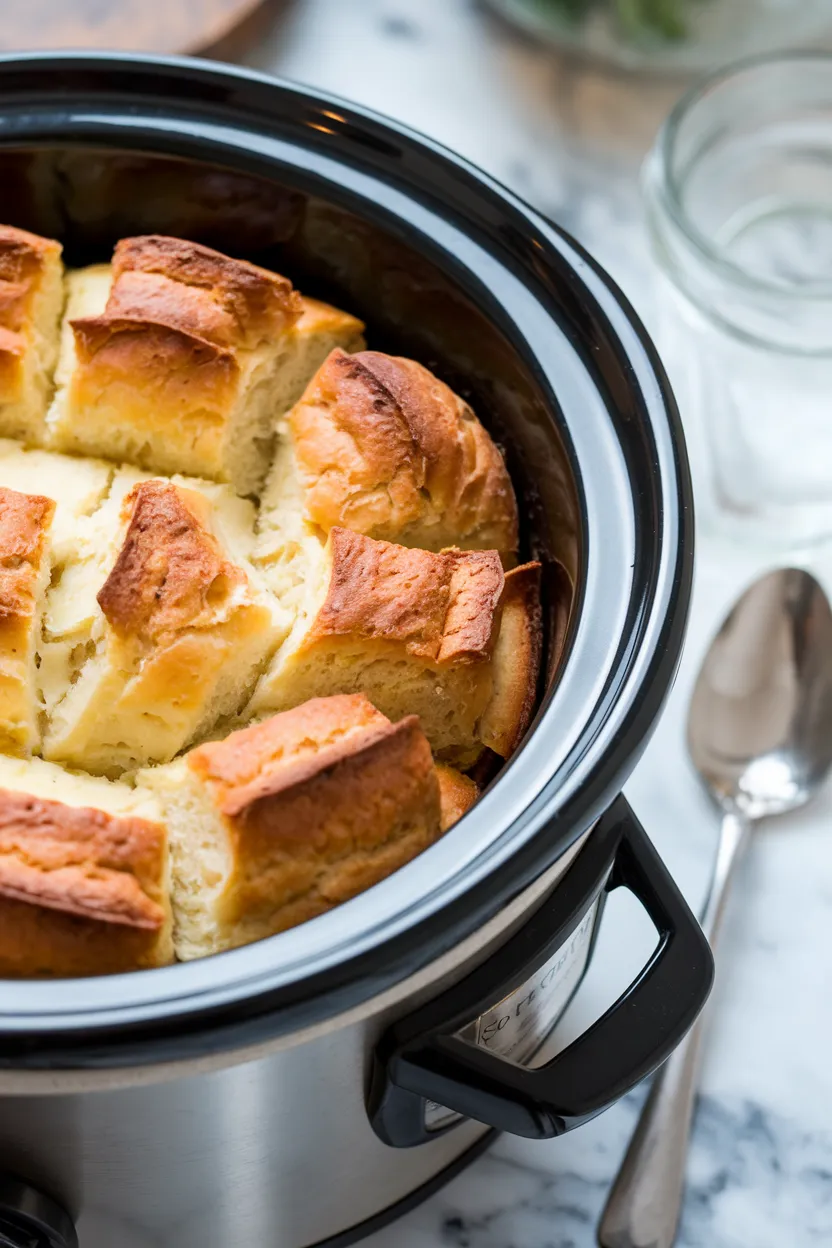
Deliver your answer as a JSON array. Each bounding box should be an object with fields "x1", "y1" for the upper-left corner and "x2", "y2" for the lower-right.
[{"x1": 49, "y1": 235, "x2": 362, "y2": 494}]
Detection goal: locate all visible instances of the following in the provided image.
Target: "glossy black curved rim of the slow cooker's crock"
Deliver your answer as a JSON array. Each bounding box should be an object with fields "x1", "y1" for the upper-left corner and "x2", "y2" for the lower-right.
[{"x1": 0, "y1": 52, "x2": 692, "y2": 1068}]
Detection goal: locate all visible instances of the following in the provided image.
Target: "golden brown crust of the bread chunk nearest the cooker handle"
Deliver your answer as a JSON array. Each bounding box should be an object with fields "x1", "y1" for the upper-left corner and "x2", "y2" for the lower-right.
[{"x1": 188, "y1": 695, "x2": 440, "y2": 938}]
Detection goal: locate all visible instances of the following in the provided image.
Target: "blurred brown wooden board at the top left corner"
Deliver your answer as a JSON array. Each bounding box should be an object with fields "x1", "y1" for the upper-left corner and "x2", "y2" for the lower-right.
[{"x1": 0, "y1": 0, "x2": 268, "y2": 52}]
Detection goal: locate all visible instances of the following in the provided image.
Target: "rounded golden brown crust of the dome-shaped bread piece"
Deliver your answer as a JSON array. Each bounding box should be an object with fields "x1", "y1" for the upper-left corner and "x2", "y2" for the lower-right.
[{"x1": 289, "y1": 349, "x2": 518, "y2": 554}]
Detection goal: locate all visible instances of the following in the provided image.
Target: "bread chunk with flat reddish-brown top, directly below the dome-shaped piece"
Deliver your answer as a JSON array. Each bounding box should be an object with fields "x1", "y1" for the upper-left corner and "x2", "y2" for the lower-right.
[{"x1": 247, "y1": 528, "x2": 536, "y2": 766}]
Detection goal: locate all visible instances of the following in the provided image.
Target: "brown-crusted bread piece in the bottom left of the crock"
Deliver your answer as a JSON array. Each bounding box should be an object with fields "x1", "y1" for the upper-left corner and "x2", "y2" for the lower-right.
[{"x1": 0, "y1": 756, "x2": 173, "y2": 978}]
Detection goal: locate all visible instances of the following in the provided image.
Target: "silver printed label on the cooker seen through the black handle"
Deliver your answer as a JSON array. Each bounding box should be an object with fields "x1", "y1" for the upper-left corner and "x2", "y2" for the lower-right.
[{"x1": 424, "y1": 901, "x2": 600, "y2": 1131}]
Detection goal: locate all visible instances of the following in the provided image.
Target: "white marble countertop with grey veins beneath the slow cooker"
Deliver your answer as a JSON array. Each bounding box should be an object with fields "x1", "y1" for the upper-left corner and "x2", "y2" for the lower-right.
[{"x1": 240, "y1": 0, "x2": 832, "y2": 1248}]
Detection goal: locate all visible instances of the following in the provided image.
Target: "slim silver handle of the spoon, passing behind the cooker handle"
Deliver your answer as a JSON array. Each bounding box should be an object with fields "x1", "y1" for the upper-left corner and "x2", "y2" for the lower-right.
[{"x1": 597, "y1": 814, "x2": 751, "y2": 1248}]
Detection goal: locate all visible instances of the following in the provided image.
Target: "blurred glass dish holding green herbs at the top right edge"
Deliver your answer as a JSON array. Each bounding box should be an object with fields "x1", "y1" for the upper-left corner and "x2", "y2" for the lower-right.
[{"x1": 490, "y1": 0, "x2": 832, "y2": 74}]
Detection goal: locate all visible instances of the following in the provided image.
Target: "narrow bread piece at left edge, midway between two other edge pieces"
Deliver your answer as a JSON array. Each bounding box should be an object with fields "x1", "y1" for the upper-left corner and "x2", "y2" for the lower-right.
[{"x1": 0, "y1": 485, "x2": 55, "y2": 758}]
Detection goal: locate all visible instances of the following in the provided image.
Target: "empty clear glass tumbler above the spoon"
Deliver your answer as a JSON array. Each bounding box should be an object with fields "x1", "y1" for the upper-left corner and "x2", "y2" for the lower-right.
[{"x1": 645, "y1": 52, "x2": 832, "y2": 545}]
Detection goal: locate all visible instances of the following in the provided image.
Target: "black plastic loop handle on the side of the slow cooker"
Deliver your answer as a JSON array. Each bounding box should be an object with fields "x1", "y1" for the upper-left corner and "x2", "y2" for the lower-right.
[{"x1": 369, "y1": 797, "x2": 713, "y2": 1147}]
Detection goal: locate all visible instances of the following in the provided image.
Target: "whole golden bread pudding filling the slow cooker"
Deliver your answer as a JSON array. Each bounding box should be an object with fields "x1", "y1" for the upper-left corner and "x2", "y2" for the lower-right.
[{"x1": 0, "y1": 227, "x2": 541, "y2": 976}]
